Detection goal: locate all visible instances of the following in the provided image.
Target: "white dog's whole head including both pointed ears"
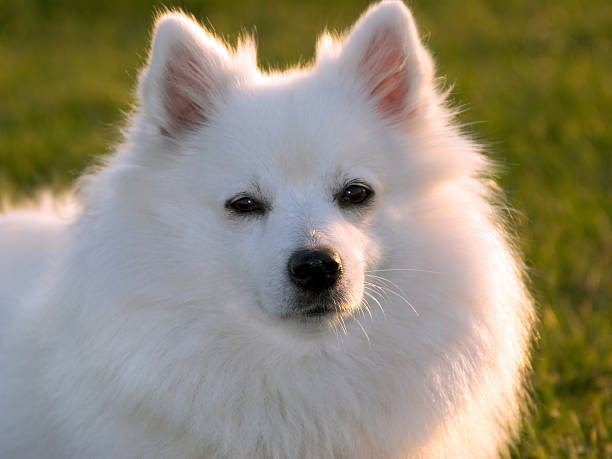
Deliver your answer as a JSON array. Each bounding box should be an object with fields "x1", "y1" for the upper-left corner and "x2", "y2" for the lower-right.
[{"x1": 129, "y1": 3, "x2": 442, "y2": 324}]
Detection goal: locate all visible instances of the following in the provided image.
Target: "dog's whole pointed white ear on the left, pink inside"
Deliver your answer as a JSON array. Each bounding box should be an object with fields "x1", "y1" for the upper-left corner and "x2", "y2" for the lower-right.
[{"x1": 139, "y1": 13, "x2": 231, "y2": 138}]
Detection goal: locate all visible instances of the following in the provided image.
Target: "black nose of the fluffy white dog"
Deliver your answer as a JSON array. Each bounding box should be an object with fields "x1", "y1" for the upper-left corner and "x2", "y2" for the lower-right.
[{"x1": 288, "y1": 248, "x2": 342, "y2": 293}]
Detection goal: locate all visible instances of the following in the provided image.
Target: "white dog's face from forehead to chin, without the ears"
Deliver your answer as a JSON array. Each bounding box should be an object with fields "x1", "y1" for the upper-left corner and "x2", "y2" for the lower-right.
[{"x1": 182, "y1": 87, "x2": 388, "y2": 321}]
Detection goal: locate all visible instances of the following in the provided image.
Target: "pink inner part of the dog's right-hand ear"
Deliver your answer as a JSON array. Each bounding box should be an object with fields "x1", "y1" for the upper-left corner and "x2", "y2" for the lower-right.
[{"x1": 359, "y1": 30, "x2": 410, "y2": 122}]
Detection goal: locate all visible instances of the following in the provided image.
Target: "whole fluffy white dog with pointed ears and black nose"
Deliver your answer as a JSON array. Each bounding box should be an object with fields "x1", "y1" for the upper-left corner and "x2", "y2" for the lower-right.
[{"x1": 0, "y1": 1, "x2": 534, "y2": 458}]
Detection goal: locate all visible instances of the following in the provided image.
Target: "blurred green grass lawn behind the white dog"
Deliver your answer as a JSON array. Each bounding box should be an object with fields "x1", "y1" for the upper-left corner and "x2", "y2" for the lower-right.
[{"x1": 0, "y1": 0, "x2": 612, "y2": 458}]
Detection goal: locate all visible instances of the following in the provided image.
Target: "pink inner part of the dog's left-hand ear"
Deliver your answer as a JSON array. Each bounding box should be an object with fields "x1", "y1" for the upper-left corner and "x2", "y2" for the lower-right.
[{"x1": 162, "y1": 47, "x2": 209, "y2": 136}]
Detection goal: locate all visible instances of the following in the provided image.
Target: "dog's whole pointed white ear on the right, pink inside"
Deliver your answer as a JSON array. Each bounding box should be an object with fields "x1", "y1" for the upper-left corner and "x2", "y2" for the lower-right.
[{"x1": 330, "y1": 0, "x2": 433, "y2": 123}]
